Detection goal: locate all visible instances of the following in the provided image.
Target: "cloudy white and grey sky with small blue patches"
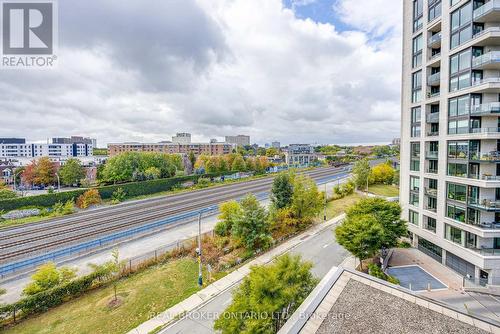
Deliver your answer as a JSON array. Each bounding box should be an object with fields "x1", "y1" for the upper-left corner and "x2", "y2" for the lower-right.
[{"x1": 0, "y1": 0, "x2": 402, "y2": 146}]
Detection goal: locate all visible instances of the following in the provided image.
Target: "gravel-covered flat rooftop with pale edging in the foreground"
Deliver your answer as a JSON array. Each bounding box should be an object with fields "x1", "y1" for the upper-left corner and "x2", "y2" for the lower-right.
[{"x1": 279, "y1": 267, "x2": 500, "y2": 334}]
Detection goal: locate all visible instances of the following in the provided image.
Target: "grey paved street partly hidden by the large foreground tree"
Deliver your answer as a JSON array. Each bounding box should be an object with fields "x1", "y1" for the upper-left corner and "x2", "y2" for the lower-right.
[{"x1": 160, "y1": 223, "x2": 349, "y2": 334}]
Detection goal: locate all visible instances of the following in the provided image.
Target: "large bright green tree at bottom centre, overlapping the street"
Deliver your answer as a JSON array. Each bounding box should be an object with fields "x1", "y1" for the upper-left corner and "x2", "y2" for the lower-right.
[{"x1": 214, "y1": 255, "x2": 318, "y2": 334}]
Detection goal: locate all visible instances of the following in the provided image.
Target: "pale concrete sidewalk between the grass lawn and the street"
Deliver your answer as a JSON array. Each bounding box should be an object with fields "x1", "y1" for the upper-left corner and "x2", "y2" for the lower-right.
[{"x1": 129, "y1": 215, "x2": 344, "y2": 334}]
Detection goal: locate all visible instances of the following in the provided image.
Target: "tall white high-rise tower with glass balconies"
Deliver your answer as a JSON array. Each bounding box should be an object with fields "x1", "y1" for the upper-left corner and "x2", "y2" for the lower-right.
[{"x1": 400, "y1": 0, "x2": 500, "y2": 284}]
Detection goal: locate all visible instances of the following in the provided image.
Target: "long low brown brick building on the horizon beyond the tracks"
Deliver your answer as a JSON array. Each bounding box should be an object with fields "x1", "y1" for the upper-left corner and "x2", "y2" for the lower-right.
[{"x1": 108, "y1": 143, "x2": 236, "y2": 157}]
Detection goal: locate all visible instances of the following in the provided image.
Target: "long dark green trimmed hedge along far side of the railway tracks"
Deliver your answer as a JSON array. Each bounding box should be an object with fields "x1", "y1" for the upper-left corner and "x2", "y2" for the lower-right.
[{"x1": 0, "y1": 175, "x2": 214, "y2": 211}]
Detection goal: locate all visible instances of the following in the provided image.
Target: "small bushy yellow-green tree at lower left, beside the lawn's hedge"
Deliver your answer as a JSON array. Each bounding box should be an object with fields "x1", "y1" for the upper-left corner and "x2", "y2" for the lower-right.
[{"x1": 23, "y1": 262, "x2": 76, "y2": 296}]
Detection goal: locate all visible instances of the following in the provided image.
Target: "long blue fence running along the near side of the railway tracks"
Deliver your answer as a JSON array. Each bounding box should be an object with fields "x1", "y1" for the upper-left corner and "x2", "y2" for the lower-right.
[{"x1": 0, "y1": 192, "x2": 268, "y2": 278}]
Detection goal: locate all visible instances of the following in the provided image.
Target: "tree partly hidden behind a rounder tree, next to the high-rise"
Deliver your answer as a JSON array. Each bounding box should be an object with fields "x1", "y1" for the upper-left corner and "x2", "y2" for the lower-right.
[{"x1": 346, "y1": 197, "x2": 407, "y2": 248}]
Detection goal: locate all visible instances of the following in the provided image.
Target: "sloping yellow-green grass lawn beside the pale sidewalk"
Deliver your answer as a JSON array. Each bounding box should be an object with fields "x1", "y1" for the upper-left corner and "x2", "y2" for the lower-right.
[{"x1": 0, "y1": 259, "x2": 219, "y2": 334}]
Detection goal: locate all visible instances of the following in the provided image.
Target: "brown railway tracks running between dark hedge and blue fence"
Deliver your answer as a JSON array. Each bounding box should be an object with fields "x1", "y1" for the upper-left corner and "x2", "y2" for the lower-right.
[{"x1": 0, "y1": 168, "x2": 348, "y2": 263}]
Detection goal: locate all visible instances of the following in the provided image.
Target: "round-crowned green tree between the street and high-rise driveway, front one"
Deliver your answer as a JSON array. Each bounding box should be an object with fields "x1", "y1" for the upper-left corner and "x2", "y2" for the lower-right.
[{"x1": 335, "y1": 215, "x2": 384, "y2": 269}]
